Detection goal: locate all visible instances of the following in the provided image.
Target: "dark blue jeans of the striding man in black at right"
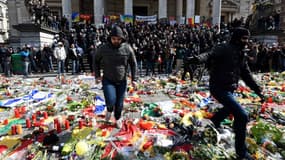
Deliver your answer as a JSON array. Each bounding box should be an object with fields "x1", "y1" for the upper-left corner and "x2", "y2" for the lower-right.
[{"x1": 210, "y1": 86, "x2": 249, "y2": 157}]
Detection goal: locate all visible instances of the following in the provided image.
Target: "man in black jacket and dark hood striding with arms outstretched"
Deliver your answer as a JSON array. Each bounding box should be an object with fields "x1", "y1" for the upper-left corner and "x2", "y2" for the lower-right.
[{"x1": 192, "y1": 28, "x2": 264, "y2": 159}]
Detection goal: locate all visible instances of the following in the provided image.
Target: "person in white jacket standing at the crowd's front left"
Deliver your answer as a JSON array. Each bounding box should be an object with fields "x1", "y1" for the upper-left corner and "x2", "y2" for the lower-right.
[{"x1": 54, "y1": 42, "x2": 66, "y2": 77}]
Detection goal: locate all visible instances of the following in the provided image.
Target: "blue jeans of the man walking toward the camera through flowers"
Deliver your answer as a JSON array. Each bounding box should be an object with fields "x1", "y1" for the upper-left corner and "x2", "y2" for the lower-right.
[{"x1": 102, "y1": 78, "x2": 127, "y2": 120}]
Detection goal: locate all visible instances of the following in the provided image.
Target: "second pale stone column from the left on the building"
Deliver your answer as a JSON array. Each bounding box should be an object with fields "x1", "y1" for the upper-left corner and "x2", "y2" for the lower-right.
[{"x1": 94, "y1": 0, "x2": 105, "y2": 26}]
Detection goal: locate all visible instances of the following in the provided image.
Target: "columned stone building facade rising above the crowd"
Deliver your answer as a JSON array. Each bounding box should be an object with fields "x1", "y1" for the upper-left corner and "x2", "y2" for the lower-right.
[{"x1": 45, "y1": 0, "x2": 253, "y2": 23}]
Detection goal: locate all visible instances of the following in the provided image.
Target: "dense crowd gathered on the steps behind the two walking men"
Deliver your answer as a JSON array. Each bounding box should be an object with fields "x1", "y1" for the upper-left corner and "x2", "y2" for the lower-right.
[{"x1": 0, "y1": 23, "x2": 285, "y2": 79}]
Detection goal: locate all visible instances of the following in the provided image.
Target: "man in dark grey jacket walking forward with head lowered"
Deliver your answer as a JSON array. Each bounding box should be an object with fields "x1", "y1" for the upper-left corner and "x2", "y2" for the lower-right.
[{"x1": 95, "y1": 26, "x2": 137, "y2": 128}]
